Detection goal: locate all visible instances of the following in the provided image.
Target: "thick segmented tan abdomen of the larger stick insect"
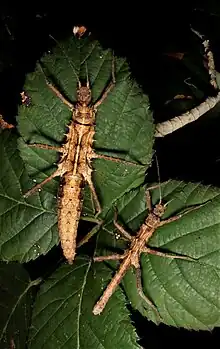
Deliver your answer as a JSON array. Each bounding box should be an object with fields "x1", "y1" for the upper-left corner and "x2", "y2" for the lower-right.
[{"x1": 58, "y1": 173, "x2": 84, "y2": 264}]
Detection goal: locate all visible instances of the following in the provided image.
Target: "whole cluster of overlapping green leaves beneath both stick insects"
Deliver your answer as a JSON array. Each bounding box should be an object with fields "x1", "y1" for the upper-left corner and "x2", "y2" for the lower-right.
[{"x1": 0, "y1": 37, "x2": 220, "y2": 349}]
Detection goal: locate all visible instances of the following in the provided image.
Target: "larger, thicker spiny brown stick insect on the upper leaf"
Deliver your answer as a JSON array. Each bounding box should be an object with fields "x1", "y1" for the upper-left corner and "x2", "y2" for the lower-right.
[{"x1": 24, "y1": 49, "x2": 137, "y2": 264}]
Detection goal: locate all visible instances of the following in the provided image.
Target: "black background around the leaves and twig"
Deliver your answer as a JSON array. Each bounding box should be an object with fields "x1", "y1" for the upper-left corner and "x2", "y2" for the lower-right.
[{"x1": 0, "y1": 1, "x2": 220, "y2": 348}]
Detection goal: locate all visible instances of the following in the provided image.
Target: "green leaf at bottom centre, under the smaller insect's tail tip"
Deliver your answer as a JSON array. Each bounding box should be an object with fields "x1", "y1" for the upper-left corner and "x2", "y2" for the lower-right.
[{"x1": 28, "y1": 257, "x2": 140, "y2": 349}]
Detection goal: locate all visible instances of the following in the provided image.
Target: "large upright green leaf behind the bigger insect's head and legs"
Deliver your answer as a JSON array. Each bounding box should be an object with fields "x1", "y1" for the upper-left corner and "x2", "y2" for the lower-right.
[{"x1": 18, "y1": 36, "x2": 154, "y2": 217}]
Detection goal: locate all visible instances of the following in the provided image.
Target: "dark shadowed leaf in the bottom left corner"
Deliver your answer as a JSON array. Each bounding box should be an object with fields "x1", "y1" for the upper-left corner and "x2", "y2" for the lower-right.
[{"x1": 0, "y1": 262, "x2": 40, "y2": 349}]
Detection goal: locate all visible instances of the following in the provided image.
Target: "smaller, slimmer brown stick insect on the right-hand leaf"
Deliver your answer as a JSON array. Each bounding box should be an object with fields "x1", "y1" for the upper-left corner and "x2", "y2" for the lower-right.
[{"x1": 93, "y1": 186, "x2": 203, "y2": 319}]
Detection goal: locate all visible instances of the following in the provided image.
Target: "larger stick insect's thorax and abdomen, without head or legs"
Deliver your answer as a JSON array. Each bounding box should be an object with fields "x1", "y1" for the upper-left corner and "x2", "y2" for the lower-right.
[{"x1": 58, "y1": 110, "x2": 95, "y2": 264}]
